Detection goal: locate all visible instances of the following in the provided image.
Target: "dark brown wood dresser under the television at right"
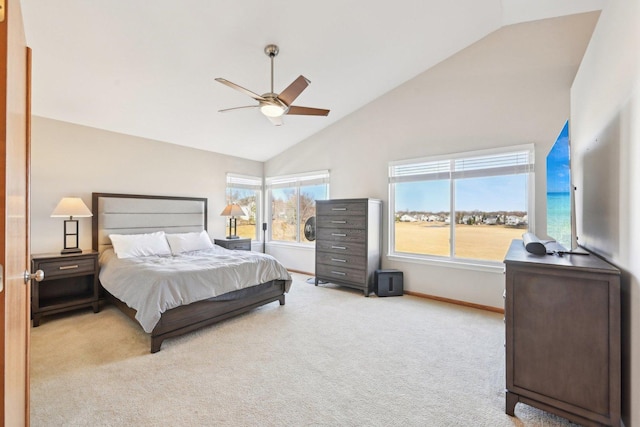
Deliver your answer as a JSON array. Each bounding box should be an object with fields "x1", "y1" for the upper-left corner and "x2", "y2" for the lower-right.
[{"x1": 504, "y1": 240, "x2": 621, "y2": 426}]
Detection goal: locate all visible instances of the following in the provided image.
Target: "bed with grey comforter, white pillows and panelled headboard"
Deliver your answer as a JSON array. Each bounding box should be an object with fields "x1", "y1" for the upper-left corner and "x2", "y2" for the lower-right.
[{"x1": 92, "y1": 193, "x2": 291, "y2": 353}]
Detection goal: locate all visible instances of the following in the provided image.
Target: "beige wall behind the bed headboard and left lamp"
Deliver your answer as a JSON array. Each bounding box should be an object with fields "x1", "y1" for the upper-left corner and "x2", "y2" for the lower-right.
[{"x1": 31, "y1": 117, "x2": 264, "y2": 253}]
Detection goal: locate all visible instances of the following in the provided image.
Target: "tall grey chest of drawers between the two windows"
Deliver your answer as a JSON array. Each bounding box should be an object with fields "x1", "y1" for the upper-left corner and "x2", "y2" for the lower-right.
[{"x1": 316, "y1": 199, "x2": 382, "y2": 296}]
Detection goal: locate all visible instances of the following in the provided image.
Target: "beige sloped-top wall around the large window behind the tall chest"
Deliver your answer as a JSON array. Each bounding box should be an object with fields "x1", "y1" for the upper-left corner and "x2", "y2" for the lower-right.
[{"x1": 265, "y1": 13, "x2": 597, "y2": 307}]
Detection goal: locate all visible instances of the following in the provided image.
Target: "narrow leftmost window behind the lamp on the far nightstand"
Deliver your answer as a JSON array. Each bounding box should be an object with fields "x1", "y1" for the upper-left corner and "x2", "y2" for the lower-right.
[{"x1": 227, "y1": 173, "x2": 262, "y2": 240}]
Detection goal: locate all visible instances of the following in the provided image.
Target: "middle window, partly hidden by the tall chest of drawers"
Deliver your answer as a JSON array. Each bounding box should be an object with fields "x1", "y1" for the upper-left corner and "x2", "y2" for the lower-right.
[{"x1": 266, "y1": 171, "x2": 329, "y2": 243}]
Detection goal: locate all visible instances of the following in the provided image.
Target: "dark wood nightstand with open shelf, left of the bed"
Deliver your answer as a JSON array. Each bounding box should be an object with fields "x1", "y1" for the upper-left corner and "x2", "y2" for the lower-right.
[{"x1": 31, "y1": 251, "x2": 100, "y2": 327}]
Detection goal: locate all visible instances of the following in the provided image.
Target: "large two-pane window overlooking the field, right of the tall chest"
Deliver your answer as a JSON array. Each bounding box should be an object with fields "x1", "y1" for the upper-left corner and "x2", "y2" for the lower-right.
[{"x1": 389, "y1": 145, "x2": 534, "y2": 262}]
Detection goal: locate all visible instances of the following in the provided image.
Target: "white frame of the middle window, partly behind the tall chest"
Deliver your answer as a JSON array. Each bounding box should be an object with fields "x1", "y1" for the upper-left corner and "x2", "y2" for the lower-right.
[{"x1": 264, "y1": 170, "x2": 331, "y2": 247}]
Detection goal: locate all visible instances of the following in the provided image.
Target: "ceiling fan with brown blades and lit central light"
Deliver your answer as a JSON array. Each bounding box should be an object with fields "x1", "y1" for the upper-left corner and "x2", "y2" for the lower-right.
[{"x1": 216, "y1": 44, "x2": 329, "y2": 126}]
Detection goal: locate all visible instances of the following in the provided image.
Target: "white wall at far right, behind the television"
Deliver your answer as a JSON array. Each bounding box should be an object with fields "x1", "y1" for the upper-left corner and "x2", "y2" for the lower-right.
[{"x1": 571, "y1": 0, "x2": 640, "y2": 427}]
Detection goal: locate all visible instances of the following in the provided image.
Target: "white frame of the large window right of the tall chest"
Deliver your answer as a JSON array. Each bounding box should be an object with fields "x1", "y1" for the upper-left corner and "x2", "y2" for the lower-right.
[{"x1": 387, "y1": 143, "x2": 535, "y2": 272}]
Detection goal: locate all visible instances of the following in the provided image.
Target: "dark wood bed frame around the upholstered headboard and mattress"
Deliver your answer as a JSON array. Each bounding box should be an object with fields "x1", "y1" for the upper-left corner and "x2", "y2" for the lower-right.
[{"x1": 92, "y1": 193, "x2": 285, "y2": 353}]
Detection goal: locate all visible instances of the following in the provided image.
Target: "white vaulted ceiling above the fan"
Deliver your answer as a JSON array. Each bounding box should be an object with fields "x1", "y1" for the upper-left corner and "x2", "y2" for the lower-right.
[{"x1": 22, "y1": 0, "x2": 604, "y2": 161}]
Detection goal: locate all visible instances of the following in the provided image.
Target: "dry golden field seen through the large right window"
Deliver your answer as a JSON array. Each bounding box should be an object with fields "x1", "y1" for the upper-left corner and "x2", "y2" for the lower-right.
[{"x1": 395, "y1": 221, "x2": 527, "y2": 261}]
